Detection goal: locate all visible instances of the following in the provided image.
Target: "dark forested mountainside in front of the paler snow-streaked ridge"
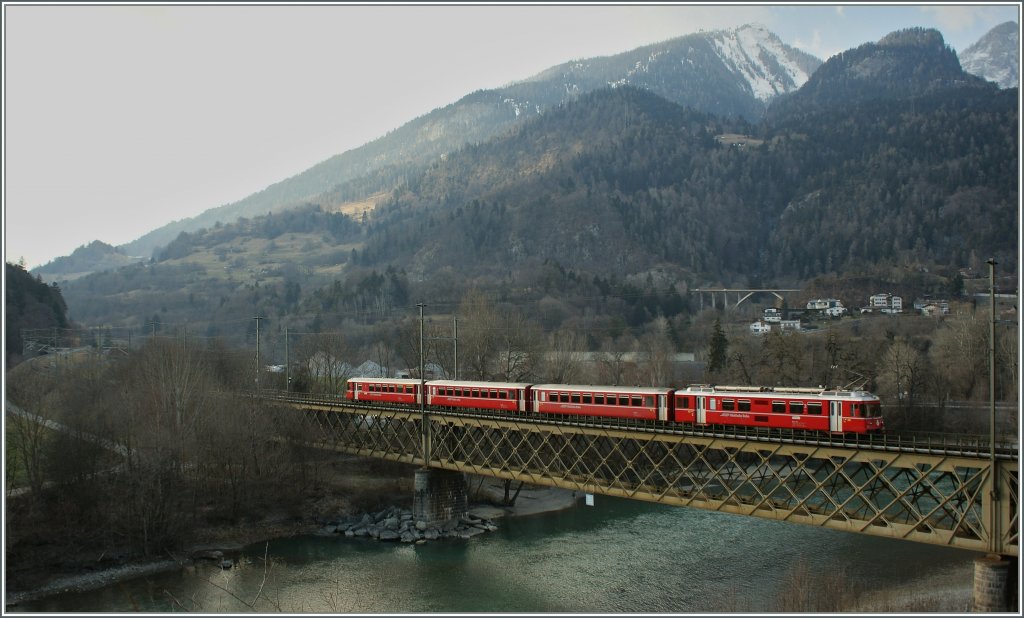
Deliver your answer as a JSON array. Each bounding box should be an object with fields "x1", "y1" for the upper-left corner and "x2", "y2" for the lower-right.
[{"x1": 48, "y1": 26, "x2": 1019, "y2": 351}]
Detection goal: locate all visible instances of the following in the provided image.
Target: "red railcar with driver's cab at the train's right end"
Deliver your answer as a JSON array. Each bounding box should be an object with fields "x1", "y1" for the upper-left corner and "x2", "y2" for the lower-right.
[{"x1": 673, "y1": 385, "x2": 884, "y2": 434}]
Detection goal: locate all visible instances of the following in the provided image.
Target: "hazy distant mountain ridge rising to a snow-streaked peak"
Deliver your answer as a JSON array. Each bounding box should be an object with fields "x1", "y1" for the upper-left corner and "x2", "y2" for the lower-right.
[{"x1": 114, "y1": 26, "x2": 821, "y2": 260}]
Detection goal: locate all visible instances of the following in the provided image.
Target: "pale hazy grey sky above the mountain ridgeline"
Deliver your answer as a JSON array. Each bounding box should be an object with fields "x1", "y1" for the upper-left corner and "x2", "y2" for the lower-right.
[{"x1": 3, "y1": 2, "x2": 1021, "y2": 268}]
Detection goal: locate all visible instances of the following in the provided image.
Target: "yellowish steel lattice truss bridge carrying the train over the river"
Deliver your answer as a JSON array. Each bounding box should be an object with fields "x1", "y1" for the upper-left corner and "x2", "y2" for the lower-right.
[{"x1": 264, "y1": 393, "x2": 1020, "y2": 556}]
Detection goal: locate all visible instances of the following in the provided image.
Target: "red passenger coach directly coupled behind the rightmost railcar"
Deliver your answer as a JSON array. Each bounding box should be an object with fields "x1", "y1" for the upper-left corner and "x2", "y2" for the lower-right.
[{"x1": 532, "y1": 384, "x2": 673, "y2": 421}]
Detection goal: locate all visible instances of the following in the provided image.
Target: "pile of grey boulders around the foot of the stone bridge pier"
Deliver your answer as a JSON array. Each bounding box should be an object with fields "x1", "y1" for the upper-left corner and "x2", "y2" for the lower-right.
[{"x1": 318, "y1": 506, "x2": 498, "y2": 543}]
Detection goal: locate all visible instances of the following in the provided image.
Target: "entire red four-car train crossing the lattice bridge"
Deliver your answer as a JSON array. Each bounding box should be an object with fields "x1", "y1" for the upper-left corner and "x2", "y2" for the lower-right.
[{"x1": 345, "y1": 378, "x2": 884, "y2": 434}]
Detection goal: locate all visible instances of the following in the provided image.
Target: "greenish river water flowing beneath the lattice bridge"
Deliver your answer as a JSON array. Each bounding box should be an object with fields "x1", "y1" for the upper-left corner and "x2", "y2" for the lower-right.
[{"x1": 17, "y1": 495, "x2": 979, "y2": 614}]
